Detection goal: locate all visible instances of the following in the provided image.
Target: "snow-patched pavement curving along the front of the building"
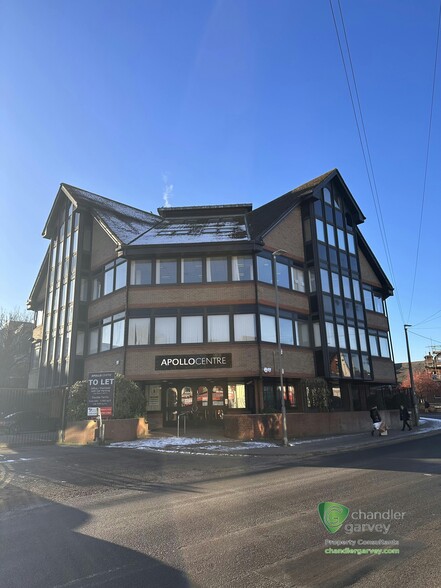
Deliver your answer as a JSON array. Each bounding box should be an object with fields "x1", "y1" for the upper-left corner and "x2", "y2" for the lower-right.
[{"x1": 107, "y1": 417, "x2": 441, "y2": 457}]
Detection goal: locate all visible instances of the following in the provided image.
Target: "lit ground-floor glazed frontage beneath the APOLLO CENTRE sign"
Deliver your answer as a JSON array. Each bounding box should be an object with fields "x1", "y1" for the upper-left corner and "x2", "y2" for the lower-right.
[{"x1": 145, "y1": 380, "x2": 250, "y2": 424}]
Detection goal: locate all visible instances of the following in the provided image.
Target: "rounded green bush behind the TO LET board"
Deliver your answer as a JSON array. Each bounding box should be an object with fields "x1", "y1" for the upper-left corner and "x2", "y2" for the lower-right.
[{"x1": 67, "y1": 374, "x2": 146, "y2": 421}]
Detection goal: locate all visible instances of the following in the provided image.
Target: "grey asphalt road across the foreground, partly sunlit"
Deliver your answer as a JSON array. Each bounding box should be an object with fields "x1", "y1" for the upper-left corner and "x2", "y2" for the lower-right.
[{"x1": 0, "y1": 435, "x2": 441, "y2": 588}]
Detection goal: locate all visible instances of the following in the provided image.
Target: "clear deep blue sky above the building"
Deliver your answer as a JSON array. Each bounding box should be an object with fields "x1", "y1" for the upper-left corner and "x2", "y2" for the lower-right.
[{"x1": 0, "y1": 0, "x2": 441, "y2": 362}]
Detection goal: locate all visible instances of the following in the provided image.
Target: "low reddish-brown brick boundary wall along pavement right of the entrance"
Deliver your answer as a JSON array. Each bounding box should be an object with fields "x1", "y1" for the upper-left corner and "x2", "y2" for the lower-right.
[{"x1": 224, "y1": 410, "x2": 400, "y2": 440}]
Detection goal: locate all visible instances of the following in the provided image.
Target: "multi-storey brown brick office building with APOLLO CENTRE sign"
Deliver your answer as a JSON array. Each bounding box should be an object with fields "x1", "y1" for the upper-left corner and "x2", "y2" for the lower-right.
[{"x1": 29, "y1": 170, "x2": 395, "y2": 423}]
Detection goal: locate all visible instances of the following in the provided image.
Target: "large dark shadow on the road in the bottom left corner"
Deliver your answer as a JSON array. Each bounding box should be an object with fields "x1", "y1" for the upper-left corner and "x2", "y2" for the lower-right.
[{"x1": 0, "y1": 487, "x2": 195, "y2": 588}]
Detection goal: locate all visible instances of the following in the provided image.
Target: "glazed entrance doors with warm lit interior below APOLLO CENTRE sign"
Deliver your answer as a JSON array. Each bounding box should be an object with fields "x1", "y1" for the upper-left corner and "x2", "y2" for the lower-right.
[{"x1": 162, "y1": 380, "x2": 228, "y2": 425}]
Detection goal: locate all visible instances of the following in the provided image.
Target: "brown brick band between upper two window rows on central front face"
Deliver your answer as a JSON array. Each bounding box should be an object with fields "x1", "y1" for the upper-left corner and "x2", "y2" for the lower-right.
[{"x1": 129, "y1": 282, "x2": 256, "y2": 308}]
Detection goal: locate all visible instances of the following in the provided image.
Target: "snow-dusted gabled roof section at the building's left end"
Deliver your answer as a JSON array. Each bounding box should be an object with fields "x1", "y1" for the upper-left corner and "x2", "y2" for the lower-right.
[{"x1": 43, "y1": 183, "x2": 160, "y2": 245}]
